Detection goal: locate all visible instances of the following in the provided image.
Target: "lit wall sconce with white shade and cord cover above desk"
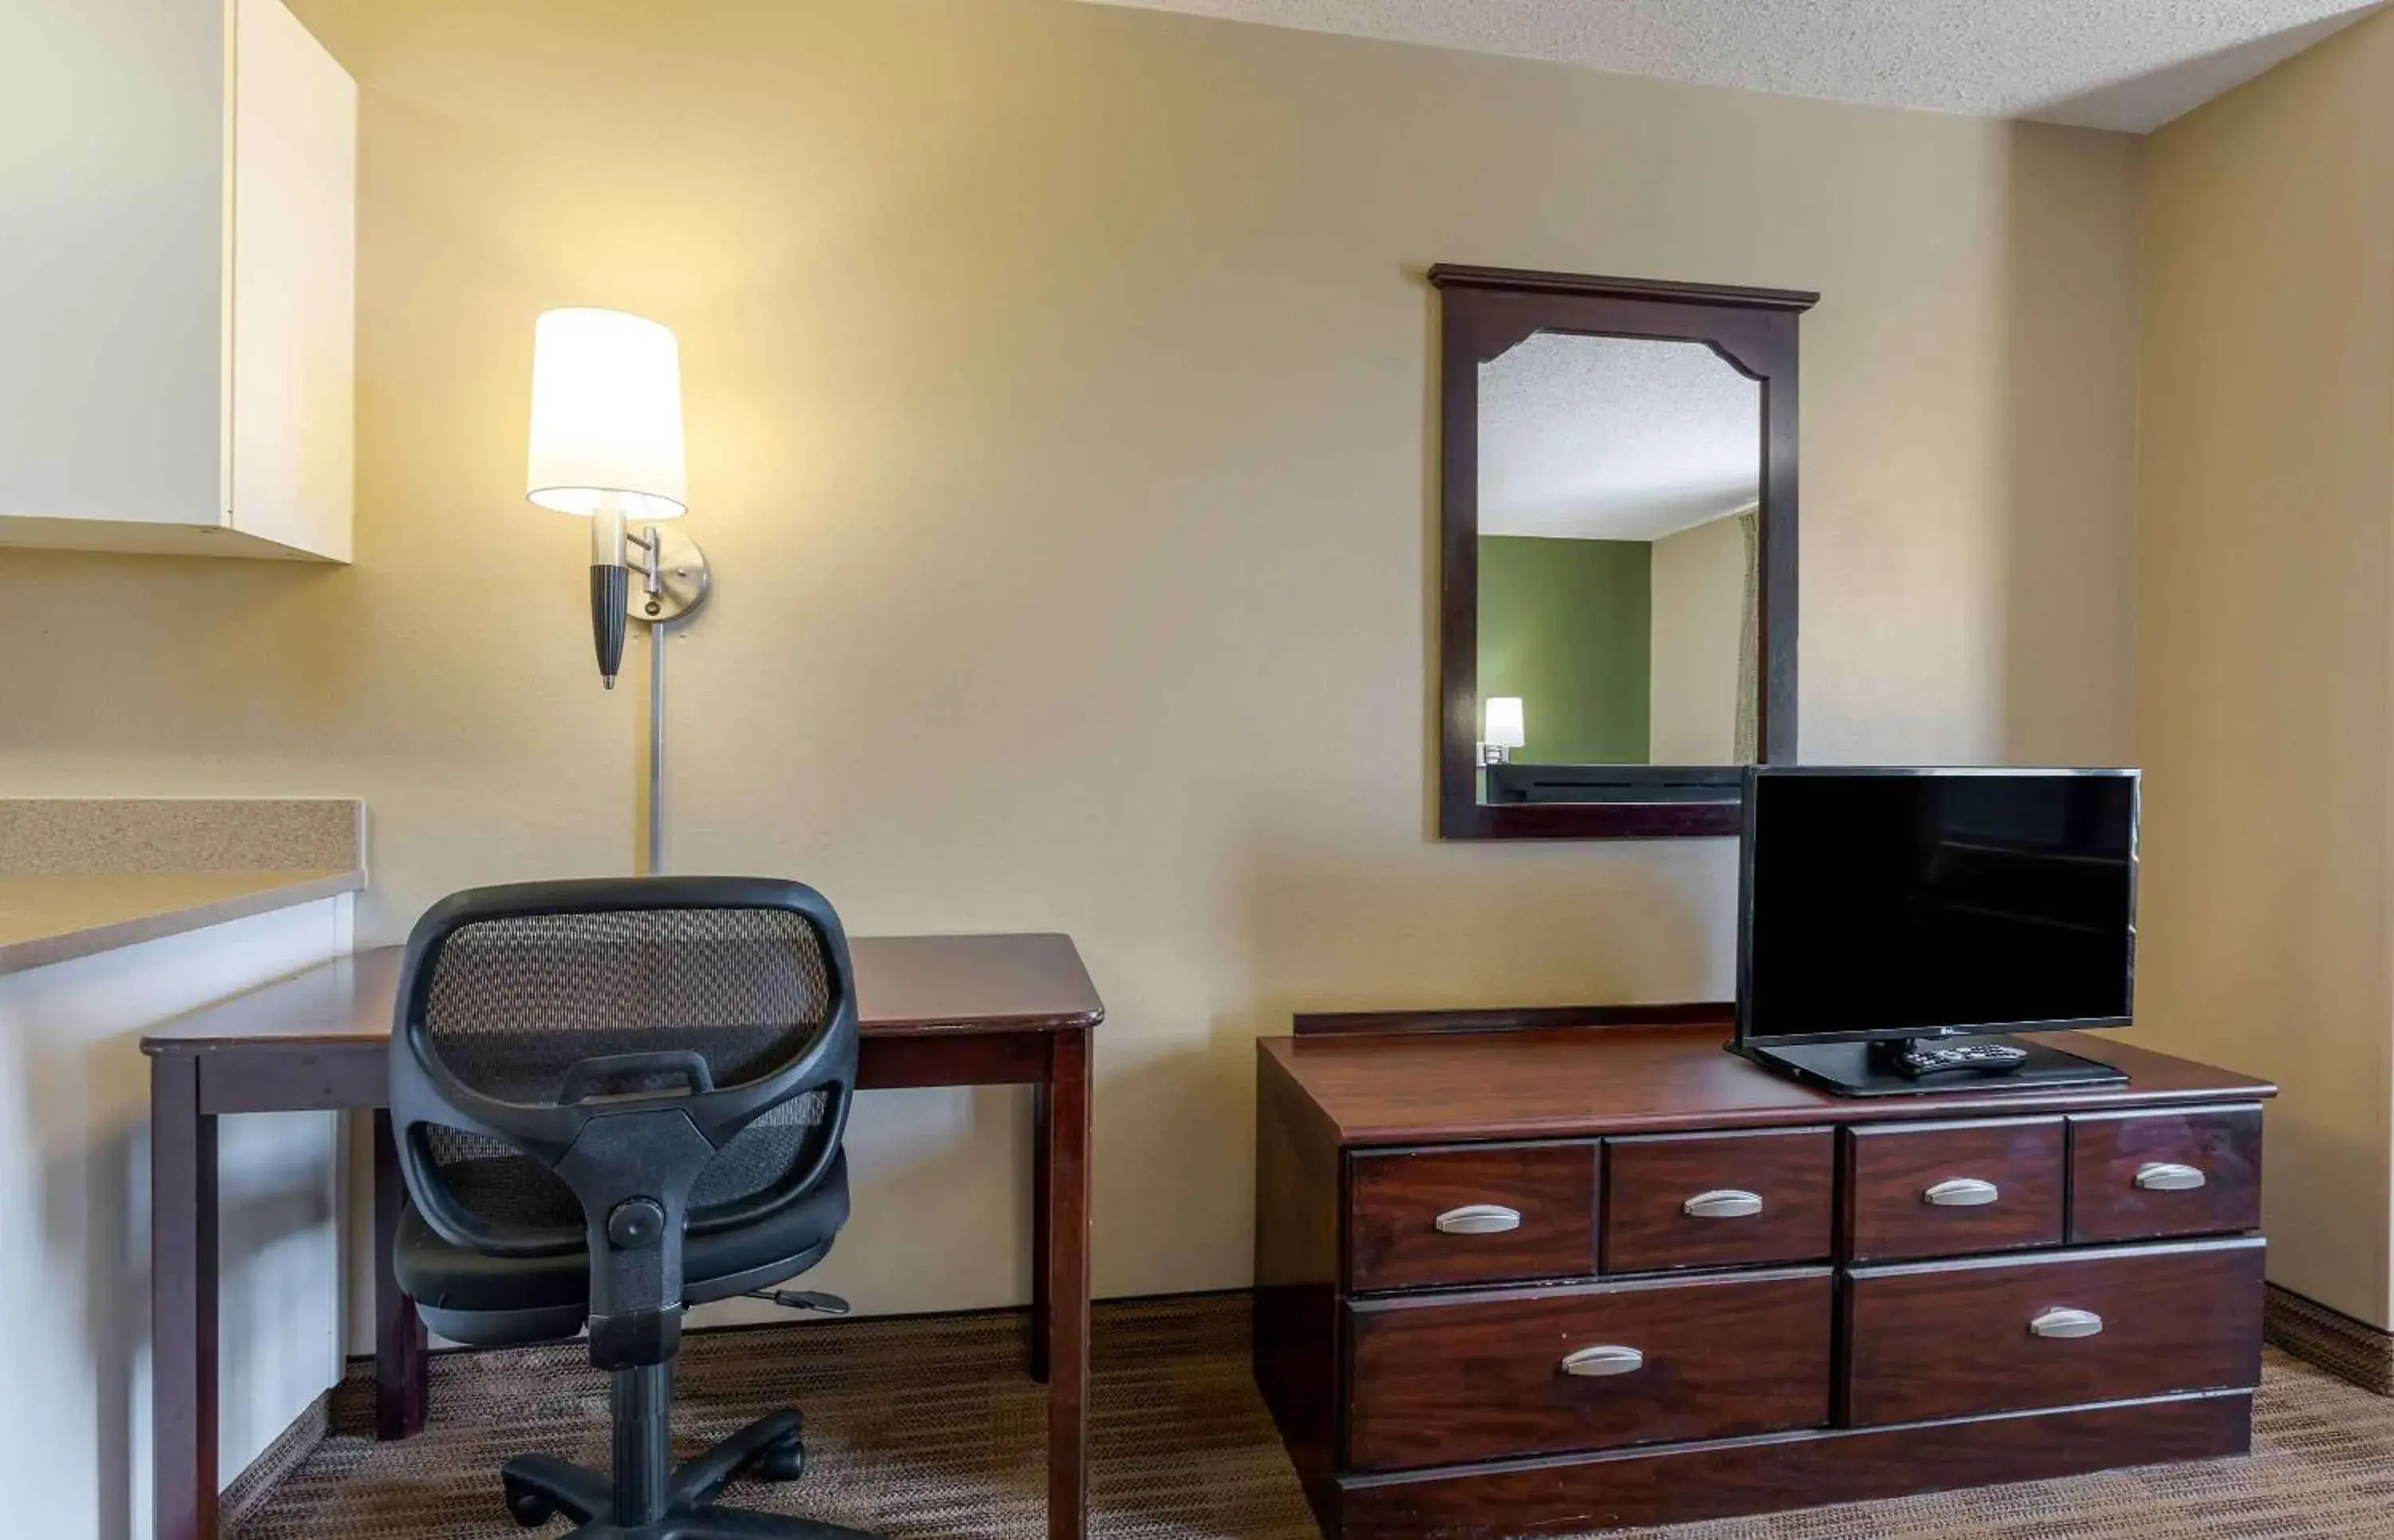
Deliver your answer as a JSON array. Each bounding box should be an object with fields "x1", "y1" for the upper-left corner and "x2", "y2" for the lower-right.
[{"x1": 524, "y1": 309, "x2": 711, "y2": 872}]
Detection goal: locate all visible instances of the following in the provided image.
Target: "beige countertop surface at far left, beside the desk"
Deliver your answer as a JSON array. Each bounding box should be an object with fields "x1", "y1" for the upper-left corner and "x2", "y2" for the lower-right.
[{"x1": 0, "y1": 867, "x2": 366, "y2": 973}]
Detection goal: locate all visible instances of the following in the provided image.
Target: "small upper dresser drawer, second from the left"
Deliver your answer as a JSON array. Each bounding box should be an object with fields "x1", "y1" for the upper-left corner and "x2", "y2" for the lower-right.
[{"x1": 1597, "y1": 1128, "x2": 1836, "y2": 1272}]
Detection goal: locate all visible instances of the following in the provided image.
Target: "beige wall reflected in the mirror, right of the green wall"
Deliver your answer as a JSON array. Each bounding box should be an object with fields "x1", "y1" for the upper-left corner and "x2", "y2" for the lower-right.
[{"x1": 1647, "y1": 515, "x2": 1752, "y2": 764}]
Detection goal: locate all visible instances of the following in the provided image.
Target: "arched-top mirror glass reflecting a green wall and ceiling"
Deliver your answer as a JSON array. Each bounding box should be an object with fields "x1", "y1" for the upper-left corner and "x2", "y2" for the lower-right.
[{"x1": 1477, "y1": 333, "x2": 1762, "y2": 800}]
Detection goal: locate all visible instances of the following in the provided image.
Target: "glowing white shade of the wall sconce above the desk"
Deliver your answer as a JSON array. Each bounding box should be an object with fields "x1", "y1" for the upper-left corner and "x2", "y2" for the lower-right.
[{"x1": 524, "y1": 309, "x2": 687, "y2": 522}]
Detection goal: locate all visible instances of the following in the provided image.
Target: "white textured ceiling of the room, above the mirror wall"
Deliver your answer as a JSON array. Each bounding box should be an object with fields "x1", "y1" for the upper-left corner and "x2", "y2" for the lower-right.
[{"x1": 1099, "y1": 0, "x2": 2382, "y2": 134}]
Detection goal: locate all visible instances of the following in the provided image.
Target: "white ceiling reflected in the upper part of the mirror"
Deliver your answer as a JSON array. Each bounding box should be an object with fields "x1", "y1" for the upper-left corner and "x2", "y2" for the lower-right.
[{"x1": 1479, "y1": 333, "x2": 1762, "y2": 541}]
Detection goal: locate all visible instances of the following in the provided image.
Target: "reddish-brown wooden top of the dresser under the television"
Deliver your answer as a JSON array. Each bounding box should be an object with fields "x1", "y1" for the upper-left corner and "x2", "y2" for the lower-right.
[{"x1": 1257, "y1": 1025, "x2": 2277, "y2": 1145}]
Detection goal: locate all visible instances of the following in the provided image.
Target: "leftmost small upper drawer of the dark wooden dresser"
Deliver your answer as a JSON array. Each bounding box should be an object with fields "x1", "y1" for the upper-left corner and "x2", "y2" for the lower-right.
[{"x1": 1348, "y1": 1143, "x2": 1597, "y2": 1291}]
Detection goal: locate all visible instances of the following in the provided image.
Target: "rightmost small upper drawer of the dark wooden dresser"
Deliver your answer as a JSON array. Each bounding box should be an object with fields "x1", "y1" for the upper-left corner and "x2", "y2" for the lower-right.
[{"x1": 2071, "y1": 1107, "x2": 2260, "y2": 1243}]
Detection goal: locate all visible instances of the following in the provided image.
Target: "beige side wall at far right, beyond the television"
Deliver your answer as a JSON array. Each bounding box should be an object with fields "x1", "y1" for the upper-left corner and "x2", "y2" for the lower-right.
[{"x1": 2135, "y1": 17, "x2": 2394, "y2": 1327}]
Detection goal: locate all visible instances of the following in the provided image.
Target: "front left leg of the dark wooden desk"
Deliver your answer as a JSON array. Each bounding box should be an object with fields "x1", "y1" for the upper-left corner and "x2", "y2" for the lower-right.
[{"x1": 151, "y1": 1054, "x2": 215, "y2": 1540}]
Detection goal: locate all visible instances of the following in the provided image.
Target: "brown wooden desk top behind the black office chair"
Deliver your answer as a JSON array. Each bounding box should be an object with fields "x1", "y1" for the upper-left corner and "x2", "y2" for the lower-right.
[{"x1": 141, "y1": 934, "x2": 1106, "y2": 1054}]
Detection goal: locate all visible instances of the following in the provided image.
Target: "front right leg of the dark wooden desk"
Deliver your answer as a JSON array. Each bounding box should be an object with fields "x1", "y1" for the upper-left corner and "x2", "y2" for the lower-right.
[{"x1": 1032, "y1": 1030, "x2": 1089, "y2": 1540}]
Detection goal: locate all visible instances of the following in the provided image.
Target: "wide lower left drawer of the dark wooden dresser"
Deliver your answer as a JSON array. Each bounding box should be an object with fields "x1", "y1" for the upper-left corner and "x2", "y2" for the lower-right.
[{"x1": 1348, "y1": 1267, "x2": 1834, "y2": 1471}]
